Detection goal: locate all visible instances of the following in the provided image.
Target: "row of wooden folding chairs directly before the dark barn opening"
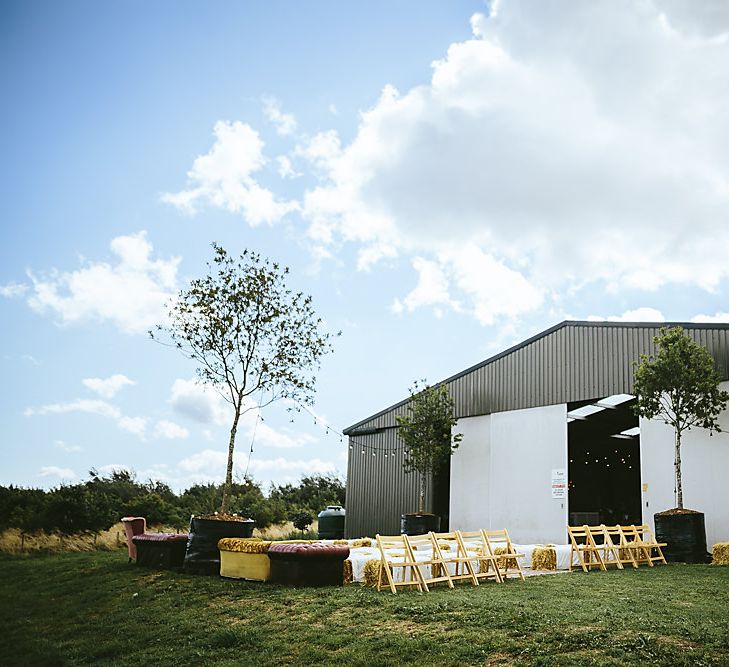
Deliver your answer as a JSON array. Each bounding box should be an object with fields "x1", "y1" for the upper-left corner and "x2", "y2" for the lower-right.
[{"x1": 567, "y1": 524, "x2": 666, "y2": 572}]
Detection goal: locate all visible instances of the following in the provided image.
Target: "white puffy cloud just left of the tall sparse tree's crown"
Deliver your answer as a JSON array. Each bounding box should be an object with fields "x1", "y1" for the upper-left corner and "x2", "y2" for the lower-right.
[{"x1": 28, "y1": 232, "x2": 180, "y2": 333}]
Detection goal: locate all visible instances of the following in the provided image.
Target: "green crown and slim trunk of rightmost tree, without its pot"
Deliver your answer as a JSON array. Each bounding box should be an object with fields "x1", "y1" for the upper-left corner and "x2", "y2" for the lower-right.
[{"x1": 634, "y1": 327, "x2": 729, "y2": 508}]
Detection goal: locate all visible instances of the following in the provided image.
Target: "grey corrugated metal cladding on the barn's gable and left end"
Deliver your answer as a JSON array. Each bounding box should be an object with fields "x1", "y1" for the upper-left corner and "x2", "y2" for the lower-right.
[{"x1": 344, "y1": 322, "x2": 729, "y2": 536}]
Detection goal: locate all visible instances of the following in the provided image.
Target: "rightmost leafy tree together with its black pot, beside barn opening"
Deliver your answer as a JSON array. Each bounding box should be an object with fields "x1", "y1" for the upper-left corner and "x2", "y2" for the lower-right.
[{"x1": 634, "y1": 327, "x2": 729, "y2": 563}]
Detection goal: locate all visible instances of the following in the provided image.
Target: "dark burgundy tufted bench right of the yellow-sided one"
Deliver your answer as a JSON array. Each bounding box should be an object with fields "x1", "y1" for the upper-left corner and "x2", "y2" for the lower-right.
[{"x1": 268, "y1": 543, "x2": 349, "y2": 586}]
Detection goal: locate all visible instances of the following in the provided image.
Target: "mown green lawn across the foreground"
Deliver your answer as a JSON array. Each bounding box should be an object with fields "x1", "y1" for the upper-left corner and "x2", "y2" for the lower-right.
[{"x1": 0, "y1": 552, "x2": 729, "y2": 666}]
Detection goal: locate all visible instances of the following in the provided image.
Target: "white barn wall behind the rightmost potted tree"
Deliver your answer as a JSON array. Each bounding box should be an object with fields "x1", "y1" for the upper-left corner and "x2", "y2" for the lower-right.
[{"x1": 640, "y1": 382, "x2": 729, "y2": 550}]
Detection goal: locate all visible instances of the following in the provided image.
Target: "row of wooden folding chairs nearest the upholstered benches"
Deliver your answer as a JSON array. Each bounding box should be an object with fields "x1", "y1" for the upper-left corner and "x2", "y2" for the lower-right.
[{"x1": 376, "y1": 529, "x2": 524, "y2": 593}]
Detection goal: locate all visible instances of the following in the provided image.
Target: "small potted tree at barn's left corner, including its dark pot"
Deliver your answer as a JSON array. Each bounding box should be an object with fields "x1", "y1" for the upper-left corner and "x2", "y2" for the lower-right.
[{"x1": 397, "y1": 380, "x2": 463, "y2": 535}]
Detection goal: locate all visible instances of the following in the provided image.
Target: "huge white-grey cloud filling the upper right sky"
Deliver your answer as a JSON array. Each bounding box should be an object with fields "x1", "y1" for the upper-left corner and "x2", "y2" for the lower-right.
[{"x1": 298, "y1": 0, "x2": 729, "y2": 323}]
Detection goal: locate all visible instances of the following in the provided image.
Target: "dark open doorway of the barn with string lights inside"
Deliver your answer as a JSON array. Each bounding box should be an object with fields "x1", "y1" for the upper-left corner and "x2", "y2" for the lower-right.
[{"x1": 567, "y1": 394, "x2": 642, "y2": 526}]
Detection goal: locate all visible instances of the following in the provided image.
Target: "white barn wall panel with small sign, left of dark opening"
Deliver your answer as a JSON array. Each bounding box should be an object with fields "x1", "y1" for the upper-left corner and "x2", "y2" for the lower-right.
[{"x1": 450, "y1": 404, "x2": 567, "y2": 544}]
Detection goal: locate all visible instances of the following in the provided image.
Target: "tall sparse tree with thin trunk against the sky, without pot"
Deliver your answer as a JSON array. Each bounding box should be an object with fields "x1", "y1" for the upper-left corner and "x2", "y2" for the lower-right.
[{"x1": 150, "y1": 244, "x2": 332, "y2": 513}]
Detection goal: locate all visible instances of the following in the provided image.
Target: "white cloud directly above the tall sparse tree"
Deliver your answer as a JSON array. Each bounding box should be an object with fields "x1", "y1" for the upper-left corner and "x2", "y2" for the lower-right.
[{"x1": 162, "y1": 121, "x2": 298, "y2": 227}]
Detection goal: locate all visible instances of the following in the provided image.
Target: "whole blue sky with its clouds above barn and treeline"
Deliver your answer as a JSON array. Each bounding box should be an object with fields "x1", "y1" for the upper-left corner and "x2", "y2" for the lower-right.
[{"x1": 0, "y1": 0, "x2": 729, "y2": 490}]
